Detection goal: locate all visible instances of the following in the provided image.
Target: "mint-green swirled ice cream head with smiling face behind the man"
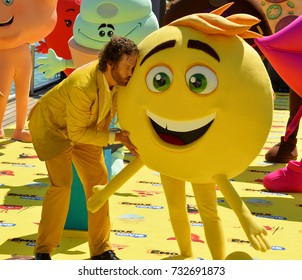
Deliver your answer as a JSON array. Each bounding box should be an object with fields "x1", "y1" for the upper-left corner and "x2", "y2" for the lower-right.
[{"x1": 73, "y1": 0, "x2": 158, "y2": 50}]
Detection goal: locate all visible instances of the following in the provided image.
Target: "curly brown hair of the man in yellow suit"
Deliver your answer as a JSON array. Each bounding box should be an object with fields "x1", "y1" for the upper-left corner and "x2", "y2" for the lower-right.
[{"x1": 99, "y1": 36, "x2": 139, "y2": 72}]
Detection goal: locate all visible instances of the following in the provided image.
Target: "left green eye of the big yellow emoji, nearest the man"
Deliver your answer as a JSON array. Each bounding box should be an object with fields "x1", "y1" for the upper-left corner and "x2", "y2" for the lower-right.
[{"x1": 146, "y1": 66, "x2": 173, "y2": 92}]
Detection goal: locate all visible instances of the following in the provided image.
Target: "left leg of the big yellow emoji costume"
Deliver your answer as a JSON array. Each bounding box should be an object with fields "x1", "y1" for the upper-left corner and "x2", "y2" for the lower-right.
[{"x1": 160, "y1": 174, "x2": 193, "y2": 258}]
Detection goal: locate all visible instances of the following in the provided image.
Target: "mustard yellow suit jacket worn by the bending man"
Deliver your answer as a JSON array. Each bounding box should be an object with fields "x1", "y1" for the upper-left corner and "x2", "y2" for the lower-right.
[{"x1": 28, "y1": 61, "x2": 118, "y2": 160}]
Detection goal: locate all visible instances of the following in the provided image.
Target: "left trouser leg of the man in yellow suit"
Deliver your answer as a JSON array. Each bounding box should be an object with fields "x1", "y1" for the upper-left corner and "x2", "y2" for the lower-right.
[{"x1": 35, "y1": 148, "x2": 72, "y2": 254}]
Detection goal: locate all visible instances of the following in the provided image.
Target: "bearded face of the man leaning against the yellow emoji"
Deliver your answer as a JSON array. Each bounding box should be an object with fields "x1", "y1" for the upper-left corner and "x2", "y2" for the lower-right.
[{"x1": 111, "y1": 55, "x2": 137, "y2": 86}]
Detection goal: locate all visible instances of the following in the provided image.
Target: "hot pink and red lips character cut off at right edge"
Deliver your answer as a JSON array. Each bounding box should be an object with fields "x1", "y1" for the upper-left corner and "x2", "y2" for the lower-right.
[{"x1": 255, "y1": 16, "x2": 302, "y2": 192}]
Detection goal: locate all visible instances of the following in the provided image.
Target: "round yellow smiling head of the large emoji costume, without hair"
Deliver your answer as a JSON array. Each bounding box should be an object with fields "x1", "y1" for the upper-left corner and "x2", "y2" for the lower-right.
[{"x1": 118, "y1": 21, "x2": 272, "y2": 183}]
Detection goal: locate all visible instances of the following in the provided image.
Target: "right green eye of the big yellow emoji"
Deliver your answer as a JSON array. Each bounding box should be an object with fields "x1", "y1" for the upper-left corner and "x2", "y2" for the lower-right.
[{"x1": 186, "y1": 66, "x2": 218, "y2": 94}]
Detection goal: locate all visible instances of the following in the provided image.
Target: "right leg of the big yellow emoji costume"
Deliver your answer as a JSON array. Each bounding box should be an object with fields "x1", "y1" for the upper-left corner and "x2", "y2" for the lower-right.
[{"x1": 192, "y1": 184, "x2": 225, "y2": 260}]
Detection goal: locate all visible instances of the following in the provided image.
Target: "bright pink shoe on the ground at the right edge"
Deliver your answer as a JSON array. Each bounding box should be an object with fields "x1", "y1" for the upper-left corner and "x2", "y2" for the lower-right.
[{"x1": 263, "y1": 160, "x2": 302, "y2": 193}]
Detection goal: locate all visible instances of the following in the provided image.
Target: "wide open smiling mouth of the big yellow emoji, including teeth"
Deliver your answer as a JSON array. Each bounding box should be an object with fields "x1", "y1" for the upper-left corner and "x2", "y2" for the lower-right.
[{"x1": 147, "y1": 111, "x2": 216, "y2": 146}]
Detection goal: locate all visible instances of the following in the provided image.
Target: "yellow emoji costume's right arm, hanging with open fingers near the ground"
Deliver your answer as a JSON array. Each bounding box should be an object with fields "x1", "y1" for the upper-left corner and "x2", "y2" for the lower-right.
[{"x1": 213, "y1": 175, "x2": 270, "y2": 252}]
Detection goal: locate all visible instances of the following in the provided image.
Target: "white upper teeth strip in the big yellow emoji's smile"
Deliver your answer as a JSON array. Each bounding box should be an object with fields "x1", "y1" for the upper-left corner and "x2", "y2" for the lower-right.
[{"x1": 147, "y1": 111, "x2": 216, "y2": 132}]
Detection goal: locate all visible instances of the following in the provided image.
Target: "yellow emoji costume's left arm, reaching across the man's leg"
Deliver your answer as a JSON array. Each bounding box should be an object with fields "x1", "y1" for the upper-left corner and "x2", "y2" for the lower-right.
[{"x1": 87, "y1": 158, "x2": 144, "y2": 213}]
